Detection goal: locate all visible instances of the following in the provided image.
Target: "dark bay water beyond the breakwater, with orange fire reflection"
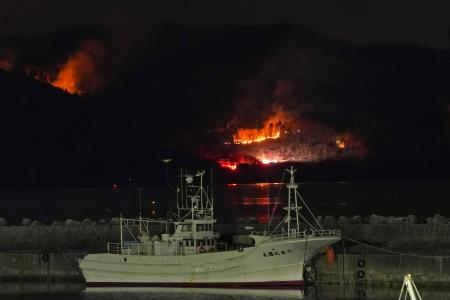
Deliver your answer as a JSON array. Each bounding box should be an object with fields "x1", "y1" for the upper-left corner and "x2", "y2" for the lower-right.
[{"x1": 0, "y1": 178, "x2": 450, "y2": 224}]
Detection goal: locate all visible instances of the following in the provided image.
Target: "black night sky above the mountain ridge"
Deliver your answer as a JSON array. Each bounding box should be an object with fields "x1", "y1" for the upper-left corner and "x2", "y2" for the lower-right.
[{"x1": 0, "y1": 0, "x2": 450, "y2": 49}]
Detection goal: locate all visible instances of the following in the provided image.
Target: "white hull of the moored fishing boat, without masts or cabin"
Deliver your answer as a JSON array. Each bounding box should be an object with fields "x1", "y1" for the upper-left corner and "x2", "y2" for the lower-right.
[{"x1": 80, "y1": 237, "x2": 339, "y2": 288}]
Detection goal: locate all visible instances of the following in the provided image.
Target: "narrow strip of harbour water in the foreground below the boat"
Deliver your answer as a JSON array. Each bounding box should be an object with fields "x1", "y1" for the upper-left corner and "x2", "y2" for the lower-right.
[{"x1": 0, "y1": 283, "x2": 450, "y2": 300}]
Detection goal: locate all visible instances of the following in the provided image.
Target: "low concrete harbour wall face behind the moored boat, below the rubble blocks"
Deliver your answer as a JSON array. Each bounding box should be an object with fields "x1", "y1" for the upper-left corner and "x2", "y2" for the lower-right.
[{"x1": 0, "y1": 252, "x2": 450, "y2": 287}]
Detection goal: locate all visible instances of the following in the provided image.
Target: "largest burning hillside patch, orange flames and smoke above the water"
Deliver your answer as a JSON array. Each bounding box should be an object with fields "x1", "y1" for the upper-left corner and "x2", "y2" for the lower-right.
[{"x1": 207, "y1": 109, "x2": 366, "y2": 171}]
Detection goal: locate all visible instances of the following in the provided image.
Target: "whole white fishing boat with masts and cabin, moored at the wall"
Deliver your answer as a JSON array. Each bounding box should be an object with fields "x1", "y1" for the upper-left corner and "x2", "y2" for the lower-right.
[{"x1": 80, "y1": 167, "x2": 340, "y2": 288}]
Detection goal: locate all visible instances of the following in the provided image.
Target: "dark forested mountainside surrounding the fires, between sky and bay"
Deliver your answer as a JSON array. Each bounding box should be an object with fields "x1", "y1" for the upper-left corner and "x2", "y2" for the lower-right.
[{"x1": 0, "y1": 24, "x2": 450, "y2": 188}]
